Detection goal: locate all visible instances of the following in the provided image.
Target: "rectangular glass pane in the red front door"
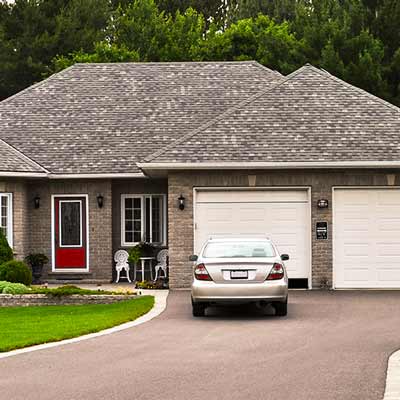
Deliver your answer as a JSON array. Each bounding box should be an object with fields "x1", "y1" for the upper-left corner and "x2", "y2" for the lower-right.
[{"x1": 60, "y1": 201, "x2": 81, "y2": 246}]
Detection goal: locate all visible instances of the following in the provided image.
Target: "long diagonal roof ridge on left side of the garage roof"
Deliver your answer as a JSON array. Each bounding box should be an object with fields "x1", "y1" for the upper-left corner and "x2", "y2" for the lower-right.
[{"x1": 142, "y1": 64, "x2": 308, "y2": 162}]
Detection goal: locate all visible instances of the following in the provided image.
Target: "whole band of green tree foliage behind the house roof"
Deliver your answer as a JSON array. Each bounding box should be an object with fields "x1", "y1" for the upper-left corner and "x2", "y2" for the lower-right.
[{"x1": 0, "y1": 0, "x2": 400, "y2": 105}]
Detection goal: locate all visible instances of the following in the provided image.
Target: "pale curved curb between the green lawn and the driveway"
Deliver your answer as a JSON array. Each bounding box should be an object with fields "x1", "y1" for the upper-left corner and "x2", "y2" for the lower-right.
[{"x1": 0, "y1": 290, "x2": 169, "y2": 359}]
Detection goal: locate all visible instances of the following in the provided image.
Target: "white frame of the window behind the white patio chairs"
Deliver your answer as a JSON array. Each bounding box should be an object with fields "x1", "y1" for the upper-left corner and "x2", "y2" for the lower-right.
[{"x1": 121, "y1": 193, "x2": 167, "y2": 247}]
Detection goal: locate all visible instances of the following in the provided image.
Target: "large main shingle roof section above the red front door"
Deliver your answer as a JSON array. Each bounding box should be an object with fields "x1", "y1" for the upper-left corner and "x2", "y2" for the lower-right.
[{"x1": 0, "y1": 61, "x2": 281, "y2": 174}]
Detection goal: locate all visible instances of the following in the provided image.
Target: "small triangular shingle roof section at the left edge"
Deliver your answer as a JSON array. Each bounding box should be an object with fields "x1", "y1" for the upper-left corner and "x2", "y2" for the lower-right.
[{"x1": 0, "y1": 140, "x2": 46, "y2": 173}]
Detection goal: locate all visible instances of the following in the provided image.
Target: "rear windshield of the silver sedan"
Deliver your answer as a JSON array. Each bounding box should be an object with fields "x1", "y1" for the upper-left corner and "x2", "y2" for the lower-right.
[{"x1": 203, "y1": 242, "x2": 275, "y2": 258}]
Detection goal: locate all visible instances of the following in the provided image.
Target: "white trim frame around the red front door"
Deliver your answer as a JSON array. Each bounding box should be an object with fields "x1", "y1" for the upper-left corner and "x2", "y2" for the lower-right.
[{"x1": 51, "y1": 194, "x2": 90, "y2": 274}]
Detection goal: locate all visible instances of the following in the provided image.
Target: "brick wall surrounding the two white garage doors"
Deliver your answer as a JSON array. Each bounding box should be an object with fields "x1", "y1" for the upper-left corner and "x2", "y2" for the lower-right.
[{"x1": 168, "y1": 170, "x2": 400, "y2": 288}]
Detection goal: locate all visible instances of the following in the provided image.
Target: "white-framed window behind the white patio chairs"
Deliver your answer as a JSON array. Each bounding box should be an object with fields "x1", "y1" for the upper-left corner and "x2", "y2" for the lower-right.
[{"x1": 121, "y1": 194, "x2": 166, "y2": 246}]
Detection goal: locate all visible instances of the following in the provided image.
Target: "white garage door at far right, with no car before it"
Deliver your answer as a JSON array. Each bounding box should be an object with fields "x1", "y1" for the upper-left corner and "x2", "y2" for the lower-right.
[{"x1": 334, "y1": 189, "x2": 400, "y2": 288}]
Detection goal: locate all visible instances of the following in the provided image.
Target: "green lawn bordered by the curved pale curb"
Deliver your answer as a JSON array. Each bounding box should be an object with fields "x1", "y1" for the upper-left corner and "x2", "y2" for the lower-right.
[{"x1": 0, "y1": 296, "x2": 154, "y2": 352}]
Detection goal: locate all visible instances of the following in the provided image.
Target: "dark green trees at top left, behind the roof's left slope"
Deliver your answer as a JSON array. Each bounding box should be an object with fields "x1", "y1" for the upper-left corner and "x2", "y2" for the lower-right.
[{"x1": 0, "y1": 0, "x2": 111, "y2": 100}]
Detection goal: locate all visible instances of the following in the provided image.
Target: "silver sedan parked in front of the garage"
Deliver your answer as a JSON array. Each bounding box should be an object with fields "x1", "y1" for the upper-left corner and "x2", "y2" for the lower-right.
[{"x1": 189, "y1": 237, "x2": 289, "y2": 317}]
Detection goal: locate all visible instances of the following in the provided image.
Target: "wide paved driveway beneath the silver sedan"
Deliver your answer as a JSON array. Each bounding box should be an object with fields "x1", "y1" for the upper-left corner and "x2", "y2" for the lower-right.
[{"x1": 0, "y1": 291, "x2": 400, "y2": 400}]
